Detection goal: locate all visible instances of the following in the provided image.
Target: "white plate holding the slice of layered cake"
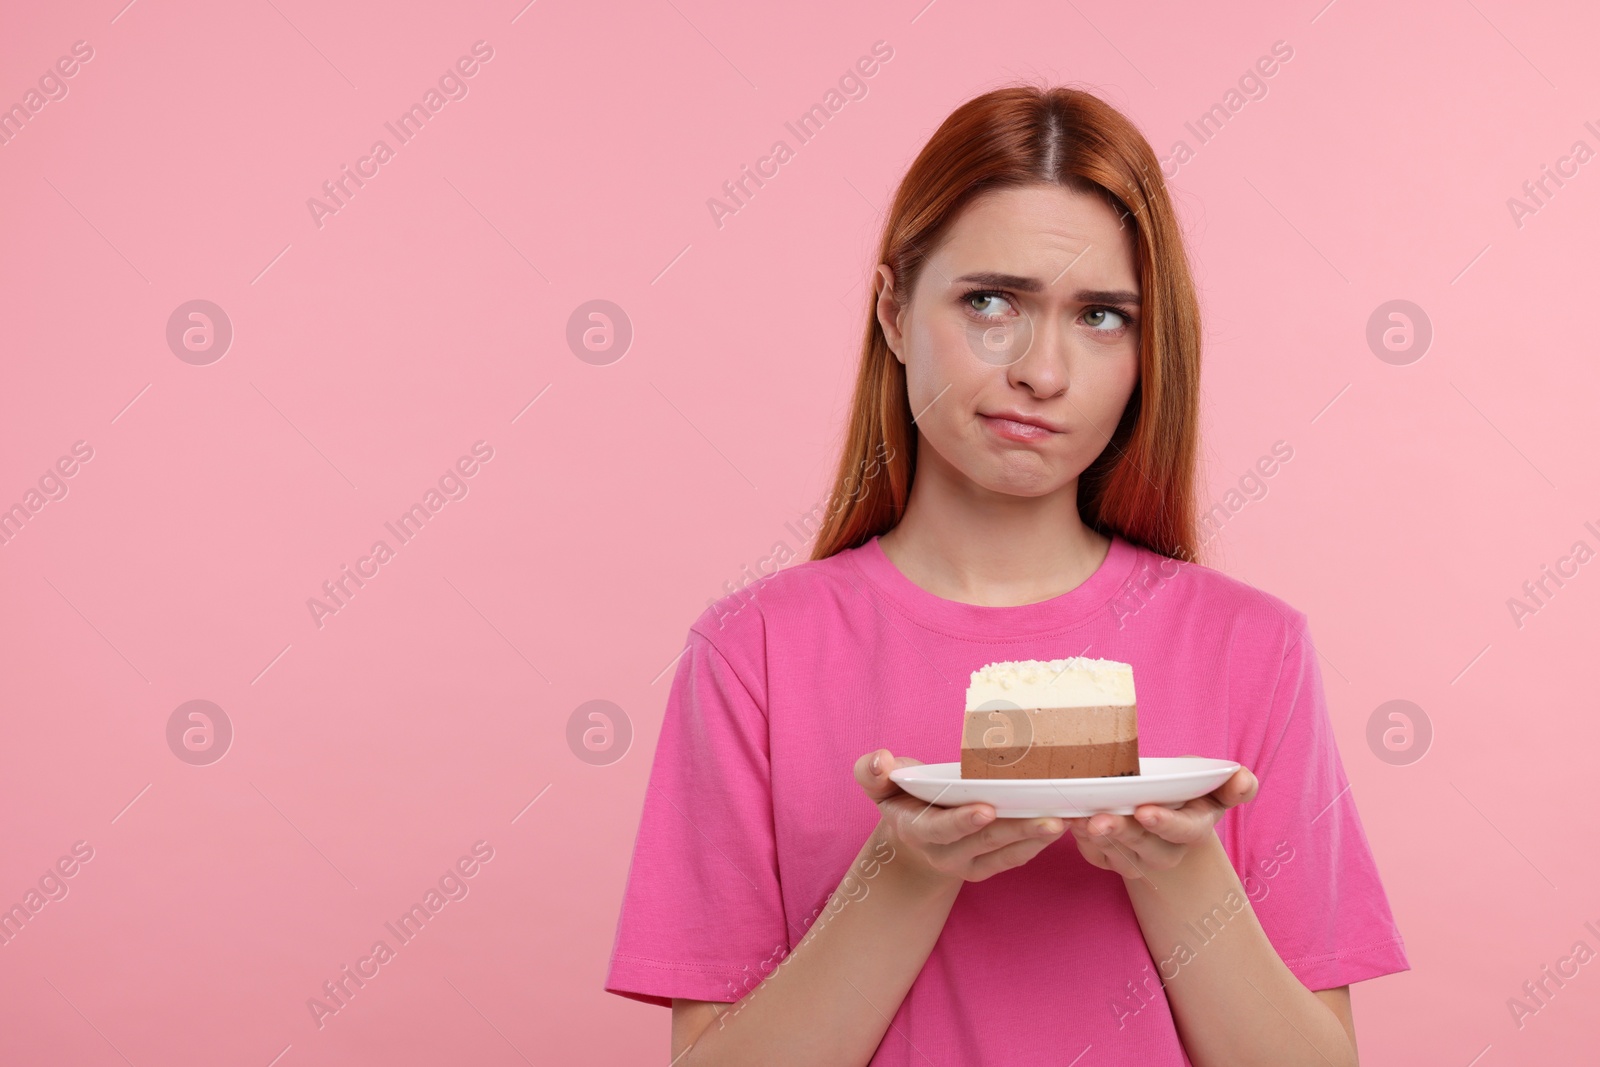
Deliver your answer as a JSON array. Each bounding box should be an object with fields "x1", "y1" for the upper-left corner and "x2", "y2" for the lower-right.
[{"x1": 890, "y1": 755, "x2": 1238, "y2": 819}]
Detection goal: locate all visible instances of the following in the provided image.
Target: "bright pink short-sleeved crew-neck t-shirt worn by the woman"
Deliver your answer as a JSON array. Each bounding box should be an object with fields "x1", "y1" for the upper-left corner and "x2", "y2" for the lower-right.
[{"x1": 605, "y1": 537, "x2": 1410, "y2": 1067}]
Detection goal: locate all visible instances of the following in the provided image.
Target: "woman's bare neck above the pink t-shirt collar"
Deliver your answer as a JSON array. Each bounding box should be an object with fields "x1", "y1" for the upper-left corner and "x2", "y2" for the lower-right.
[{"x1": 878, "y1": 446, "x2": 1110, "y2": 606}]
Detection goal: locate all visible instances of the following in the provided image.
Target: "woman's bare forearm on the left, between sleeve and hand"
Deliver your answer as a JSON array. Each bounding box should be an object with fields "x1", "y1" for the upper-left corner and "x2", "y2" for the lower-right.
[{"x1": 672, "y1": 824, "x2": 962, "y2": 1067}]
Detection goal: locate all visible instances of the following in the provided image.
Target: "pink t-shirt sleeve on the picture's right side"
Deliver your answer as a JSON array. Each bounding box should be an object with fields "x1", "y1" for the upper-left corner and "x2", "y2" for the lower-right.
[{"x1": 1229, "y1": 611, "x2": 1411, "y2": 990}]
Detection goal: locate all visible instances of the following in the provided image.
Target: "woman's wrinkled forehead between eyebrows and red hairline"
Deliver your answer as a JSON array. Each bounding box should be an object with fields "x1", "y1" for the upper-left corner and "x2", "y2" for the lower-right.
[{"x1": 923, "y1": 184, "x2": 1138, "y2": 291}]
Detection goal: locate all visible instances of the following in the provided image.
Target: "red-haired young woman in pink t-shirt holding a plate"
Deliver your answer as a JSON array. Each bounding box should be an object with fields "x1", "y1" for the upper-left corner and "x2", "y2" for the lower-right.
[{"x1": 605, "y1": 86, "x2": 1410, "y2": 1067}]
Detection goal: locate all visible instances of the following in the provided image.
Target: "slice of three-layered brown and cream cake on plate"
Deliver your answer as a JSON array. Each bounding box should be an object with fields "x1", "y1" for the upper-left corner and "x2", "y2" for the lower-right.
[{"x1": 962, "y1": 656, "x2": 1139, "y2": 777}]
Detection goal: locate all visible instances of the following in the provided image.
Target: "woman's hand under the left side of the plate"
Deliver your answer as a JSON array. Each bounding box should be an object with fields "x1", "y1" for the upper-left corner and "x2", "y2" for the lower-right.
[{"x1": 856, "y1": 749, "x2": 1066, "y2": 881}]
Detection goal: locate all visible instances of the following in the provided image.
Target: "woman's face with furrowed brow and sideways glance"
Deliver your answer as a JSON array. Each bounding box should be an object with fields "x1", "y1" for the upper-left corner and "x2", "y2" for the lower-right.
[{"x1": 877, "y1": 184, "x2": 1139, "y2": 496}]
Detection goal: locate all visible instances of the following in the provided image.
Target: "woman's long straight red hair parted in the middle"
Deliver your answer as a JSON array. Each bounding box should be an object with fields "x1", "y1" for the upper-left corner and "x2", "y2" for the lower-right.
[{"x1": 811, "y1": 85, "x2": 1200, "y2": 561}]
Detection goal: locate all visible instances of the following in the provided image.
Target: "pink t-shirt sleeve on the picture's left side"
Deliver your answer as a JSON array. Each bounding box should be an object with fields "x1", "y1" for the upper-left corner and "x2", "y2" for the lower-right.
[{"x1": 605, "y1": 629, "x2": 789, "y2": 1006}]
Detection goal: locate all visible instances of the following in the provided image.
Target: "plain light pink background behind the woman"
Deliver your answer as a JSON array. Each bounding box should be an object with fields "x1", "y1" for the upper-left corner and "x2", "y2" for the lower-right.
[{"x1": 0, "y1": 0, "x2": 1600, "y2": 1067}]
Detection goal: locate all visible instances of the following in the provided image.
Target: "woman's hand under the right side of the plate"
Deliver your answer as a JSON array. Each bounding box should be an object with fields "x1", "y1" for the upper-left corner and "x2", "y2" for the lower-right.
[{"x1": 1067, "y1": 766, "x2": 1261, "y2": 880}]
